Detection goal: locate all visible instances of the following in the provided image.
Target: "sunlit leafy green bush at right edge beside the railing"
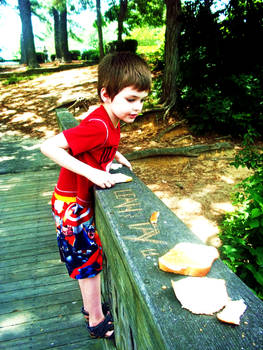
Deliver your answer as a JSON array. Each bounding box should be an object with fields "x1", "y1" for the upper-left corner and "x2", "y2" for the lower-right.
[{"x1": 219, "y1": 130, "x2": 263, "y2": 299}]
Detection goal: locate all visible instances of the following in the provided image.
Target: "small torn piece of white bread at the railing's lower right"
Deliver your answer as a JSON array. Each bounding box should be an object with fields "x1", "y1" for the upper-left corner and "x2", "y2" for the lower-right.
[{"x1": 216, "y1": 299, "x2": 247, "y2": 326}]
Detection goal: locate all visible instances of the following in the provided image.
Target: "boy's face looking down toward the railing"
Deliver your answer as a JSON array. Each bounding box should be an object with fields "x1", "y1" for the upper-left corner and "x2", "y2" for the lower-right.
[{"x1": 104, "y1": 86, "x2": 148, "y2": 126}]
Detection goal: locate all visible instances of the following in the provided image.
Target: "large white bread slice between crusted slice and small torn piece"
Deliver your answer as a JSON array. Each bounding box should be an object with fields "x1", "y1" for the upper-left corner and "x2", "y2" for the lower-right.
[{"x1": 171, "y1": 277, "x2": 229, "y2": 315}]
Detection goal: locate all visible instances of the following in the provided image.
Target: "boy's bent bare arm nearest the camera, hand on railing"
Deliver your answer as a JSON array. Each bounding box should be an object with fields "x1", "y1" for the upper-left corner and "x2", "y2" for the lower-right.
[{"x1": 40, "y1": 133, "x2": 115, "y2": 188}]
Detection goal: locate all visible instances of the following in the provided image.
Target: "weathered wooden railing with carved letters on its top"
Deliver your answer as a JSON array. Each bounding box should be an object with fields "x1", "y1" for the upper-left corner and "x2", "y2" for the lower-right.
[{"x1": 56, "y1": 107, "x2": 263, "y2": 350}]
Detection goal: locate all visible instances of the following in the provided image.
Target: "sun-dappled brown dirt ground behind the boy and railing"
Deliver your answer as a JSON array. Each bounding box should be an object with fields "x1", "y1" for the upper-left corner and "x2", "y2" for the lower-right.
[{"x1": 0, "y1": 66, "x2": 254, "y2": 246}]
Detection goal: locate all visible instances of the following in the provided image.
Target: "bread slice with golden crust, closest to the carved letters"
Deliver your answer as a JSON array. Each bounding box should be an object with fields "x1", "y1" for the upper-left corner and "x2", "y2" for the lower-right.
[{"x1": 158, "y1": 242, "x2": 219, "y2": 277}]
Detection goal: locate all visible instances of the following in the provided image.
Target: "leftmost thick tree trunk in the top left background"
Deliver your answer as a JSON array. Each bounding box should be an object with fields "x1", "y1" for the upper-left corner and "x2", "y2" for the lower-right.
[{"x1": 18, "y1": 0, "x2": 39, "y2": 68}]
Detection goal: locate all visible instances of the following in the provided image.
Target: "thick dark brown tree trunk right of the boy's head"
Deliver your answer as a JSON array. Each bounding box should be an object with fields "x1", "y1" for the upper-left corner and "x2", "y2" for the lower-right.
[{"x1": 162, "y1": 0, "x2": 181, "y2": 109}]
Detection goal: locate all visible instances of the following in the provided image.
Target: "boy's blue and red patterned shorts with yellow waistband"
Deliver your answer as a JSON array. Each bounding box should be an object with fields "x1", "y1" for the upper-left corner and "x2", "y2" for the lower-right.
[{"x1": 51, "y1": 193, "x2": 102, "y2": 279}]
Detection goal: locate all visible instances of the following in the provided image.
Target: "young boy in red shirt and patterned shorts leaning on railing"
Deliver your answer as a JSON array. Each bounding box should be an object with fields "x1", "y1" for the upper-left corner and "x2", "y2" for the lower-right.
[{"x1": 41, "y1": 52, "x2": 151, "y2": 339}]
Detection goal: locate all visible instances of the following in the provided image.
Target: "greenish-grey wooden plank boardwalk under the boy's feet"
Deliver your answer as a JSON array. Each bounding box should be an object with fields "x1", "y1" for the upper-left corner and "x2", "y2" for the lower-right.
[{"x1": 0, "y1": 140, "x2": 102, "y2": 350}]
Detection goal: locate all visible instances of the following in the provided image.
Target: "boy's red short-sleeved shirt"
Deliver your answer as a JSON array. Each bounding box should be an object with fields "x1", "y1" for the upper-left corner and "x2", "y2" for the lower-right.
[{"x1": 55, "y1": 106, "x2": 120, "y2": 205}]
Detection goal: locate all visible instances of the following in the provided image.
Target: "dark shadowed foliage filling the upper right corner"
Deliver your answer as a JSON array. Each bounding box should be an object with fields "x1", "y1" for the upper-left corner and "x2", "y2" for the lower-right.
[{"x1": 178, "y1": 1, "x2": 263, "y2": 136}]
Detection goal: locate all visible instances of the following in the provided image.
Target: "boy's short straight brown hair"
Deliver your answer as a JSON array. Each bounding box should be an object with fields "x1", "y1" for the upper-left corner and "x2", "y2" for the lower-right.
[{"x1": 98, "y1": 52, "x2": 152, "y2": 99}]
